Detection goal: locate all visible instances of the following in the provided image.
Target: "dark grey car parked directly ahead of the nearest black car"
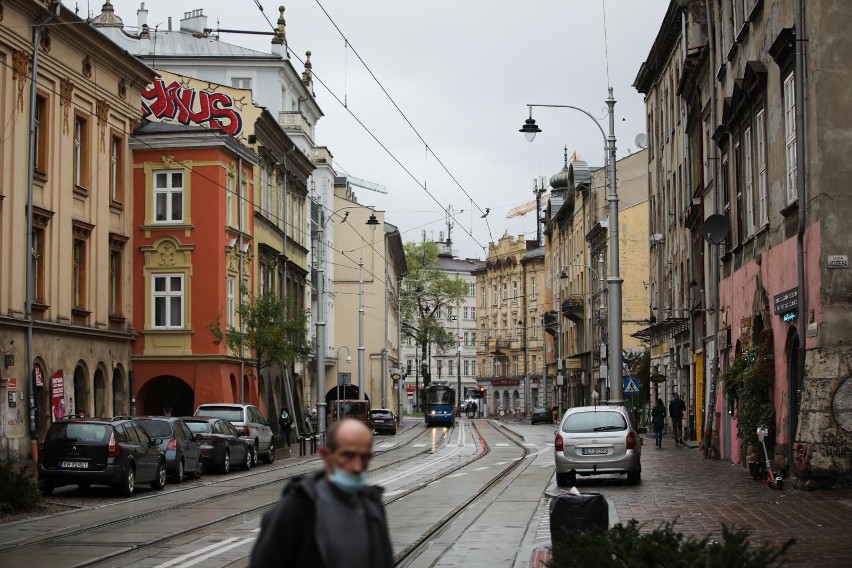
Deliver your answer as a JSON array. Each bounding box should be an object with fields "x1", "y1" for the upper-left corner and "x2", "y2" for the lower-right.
[{"x1": 137, "y1": 416, "x2": 204, "y2": 483}]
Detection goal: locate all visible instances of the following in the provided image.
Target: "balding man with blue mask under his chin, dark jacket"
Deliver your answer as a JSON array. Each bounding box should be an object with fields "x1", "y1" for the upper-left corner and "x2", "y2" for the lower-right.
[{"x1": 250, "y1": 418, "x2": 393, "y2": 568}]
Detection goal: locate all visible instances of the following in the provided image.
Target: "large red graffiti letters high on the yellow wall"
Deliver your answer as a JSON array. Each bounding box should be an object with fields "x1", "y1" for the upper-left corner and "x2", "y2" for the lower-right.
[{"x1": 142, "y1": 78, "x2": 243, "y2": 136}]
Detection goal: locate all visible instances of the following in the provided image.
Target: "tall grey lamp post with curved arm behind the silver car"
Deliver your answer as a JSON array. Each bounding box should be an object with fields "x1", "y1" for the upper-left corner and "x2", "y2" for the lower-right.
[{"x1": 520, "y1": 87, "x2": 624, "y2": 404}]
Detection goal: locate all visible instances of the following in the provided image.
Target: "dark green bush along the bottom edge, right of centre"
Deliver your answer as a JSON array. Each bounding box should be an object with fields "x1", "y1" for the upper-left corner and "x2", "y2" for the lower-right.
[{"x1": 548, "y1": 520, "x2": 795, "y2": 568}]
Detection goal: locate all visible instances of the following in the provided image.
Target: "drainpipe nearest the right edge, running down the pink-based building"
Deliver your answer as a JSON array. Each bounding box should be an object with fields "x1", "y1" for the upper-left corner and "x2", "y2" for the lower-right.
[{"x1": 787, "y1": 0, "x2": 808, "y2": 478}]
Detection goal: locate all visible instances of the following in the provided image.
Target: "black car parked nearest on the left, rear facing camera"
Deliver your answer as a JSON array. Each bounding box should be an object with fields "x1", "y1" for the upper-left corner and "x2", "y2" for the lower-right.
[{"x1": 38, "y1": 417, "x2": 166, "y2": 497}]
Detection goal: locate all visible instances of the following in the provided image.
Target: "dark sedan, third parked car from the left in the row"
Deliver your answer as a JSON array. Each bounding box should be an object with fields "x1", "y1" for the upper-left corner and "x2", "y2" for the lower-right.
[{"x1": 183, "y1": 416, "x2": 254, "y2": 473}]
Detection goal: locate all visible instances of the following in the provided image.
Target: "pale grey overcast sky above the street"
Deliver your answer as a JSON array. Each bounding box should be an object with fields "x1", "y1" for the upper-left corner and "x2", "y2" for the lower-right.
[{"x1": 103, "y1": 0, "x2": 669, "y2": 258}]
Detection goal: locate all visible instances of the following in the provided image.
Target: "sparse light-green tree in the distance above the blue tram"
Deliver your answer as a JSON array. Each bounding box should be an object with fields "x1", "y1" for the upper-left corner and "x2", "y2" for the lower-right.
[{"x1": 401, "y1": 242, "x2": 468, "y2": 386}]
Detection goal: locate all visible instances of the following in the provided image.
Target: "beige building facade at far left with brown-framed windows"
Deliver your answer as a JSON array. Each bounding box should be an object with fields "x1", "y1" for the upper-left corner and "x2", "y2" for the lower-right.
[{"x1": 0, "y1": 0, "x2": 154, "y2": 457}]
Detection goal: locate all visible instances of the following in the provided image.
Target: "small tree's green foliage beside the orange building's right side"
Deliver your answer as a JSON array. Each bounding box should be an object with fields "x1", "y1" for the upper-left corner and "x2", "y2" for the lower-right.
[{"x1": 208, "y1": 292, "x2": 313, "y2": 376}]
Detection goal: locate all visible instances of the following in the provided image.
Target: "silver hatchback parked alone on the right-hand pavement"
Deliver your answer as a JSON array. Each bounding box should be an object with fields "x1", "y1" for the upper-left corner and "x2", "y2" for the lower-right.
[{"x1": 554, "y1": 406, "x2": 642, "y2": 487}]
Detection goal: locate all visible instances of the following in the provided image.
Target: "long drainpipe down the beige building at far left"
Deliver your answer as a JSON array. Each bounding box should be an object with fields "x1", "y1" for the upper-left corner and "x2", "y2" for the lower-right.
[{"x1": 24, "y1": 0, "x2": 62, "y2": 460}]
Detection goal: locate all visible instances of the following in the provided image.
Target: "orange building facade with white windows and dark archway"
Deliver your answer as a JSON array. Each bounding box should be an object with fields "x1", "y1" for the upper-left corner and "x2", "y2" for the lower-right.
[{"x1": 131, "y1": 123, "x2": 259, "y2": 416}]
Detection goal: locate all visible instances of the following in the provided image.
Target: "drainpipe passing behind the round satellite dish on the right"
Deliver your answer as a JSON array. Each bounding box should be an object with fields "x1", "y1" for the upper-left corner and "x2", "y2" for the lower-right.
[{"x1": 702, "y1": 2, "x2": 722, "y2": 457}]
